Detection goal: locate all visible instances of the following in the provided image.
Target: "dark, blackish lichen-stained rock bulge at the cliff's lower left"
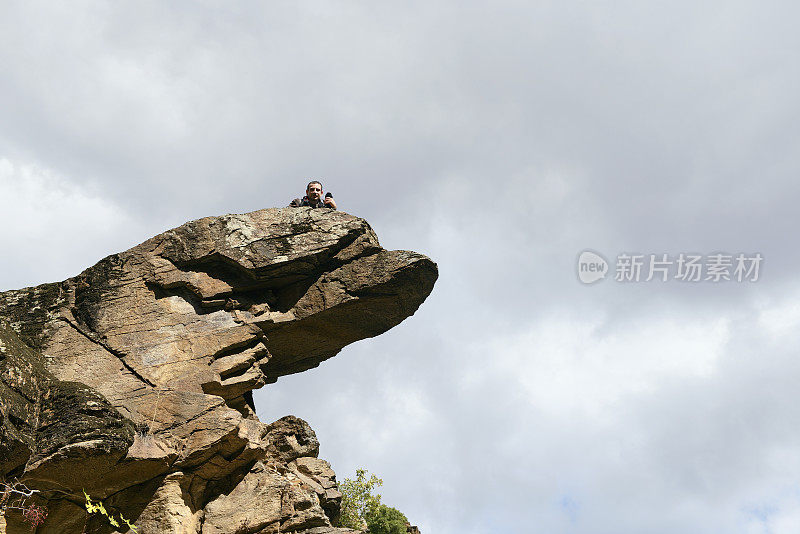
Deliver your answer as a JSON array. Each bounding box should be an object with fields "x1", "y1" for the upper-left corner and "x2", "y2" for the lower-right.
[{"x1": 0, "y1": 324, "x2": 134, "y2": 491}]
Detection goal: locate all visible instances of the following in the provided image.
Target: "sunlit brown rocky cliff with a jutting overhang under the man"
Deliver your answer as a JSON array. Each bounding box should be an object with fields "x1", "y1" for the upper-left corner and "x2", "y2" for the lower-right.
[{"x1": 0, "y1": 208, "x2": 437, "y2": 534}]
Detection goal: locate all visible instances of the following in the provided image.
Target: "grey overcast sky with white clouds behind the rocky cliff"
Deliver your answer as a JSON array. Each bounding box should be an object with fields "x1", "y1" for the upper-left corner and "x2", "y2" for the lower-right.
[{"x1": 0, "y1": 0, "x2": 800, "y2": 534}]
